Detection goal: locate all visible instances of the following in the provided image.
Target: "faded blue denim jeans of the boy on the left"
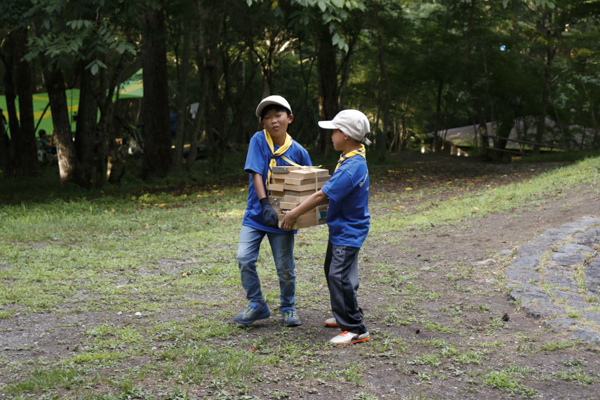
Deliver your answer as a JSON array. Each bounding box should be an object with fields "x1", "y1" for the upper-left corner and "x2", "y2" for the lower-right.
[{"x1": 237, "y1": 225, "x2": 296, "y2": 312}]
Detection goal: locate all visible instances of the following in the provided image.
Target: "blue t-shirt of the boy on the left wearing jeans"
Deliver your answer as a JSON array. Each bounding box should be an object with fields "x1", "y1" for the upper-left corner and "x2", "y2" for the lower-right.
[{"x1": 242, "y1": 131, "x2": 312, "y2": 234}]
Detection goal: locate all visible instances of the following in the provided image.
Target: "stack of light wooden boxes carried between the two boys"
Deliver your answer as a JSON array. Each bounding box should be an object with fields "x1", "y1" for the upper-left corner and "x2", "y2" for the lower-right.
[{"x1": 269, "y1": 166, "x2": 330, "y2": 229}]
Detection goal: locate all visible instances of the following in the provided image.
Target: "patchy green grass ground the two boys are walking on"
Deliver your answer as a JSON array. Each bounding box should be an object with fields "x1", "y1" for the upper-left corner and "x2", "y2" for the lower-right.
[{"x1": 0, "y1": 155, "x2": 600, "y2": 400}]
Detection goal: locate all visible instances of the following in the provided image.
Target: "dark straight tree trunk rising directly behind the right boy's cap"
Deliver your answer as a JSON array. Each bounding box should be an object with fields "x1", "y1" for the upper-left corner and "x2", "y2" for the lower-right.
[{"x1": 317, "y1": 25, "x2": 339, "y2": 152}]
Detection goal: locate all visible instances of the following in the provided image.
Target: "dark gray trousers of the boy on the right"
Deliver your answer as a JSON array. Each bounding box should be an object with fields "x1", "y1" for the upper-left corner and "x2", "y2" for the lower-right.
[{"x1": 325, "y1": 242, "x2": 367, "y2": 334}]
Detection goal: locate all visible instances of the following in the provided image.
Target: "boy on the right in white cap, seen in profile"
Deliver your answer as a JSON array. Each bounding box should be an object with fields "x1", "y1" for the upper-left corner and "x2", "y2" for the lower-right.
[{"x1": 282, "y1": 110, "x2": 371, "y2": 345}]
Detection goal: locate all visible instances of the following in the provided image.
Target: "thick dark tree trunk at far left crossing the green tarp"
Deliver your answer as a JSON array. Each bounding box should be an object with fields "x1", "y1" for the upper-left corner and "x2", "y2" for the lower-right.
[{"x1": 7, "y1": 28, "x2": 39, "y2": 177}]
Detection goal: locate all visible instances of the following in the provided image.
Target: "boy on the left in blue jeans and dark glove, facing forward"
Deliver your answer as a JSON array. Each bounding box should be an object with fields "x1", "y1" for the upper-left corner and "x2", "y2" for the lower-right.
[{"x1": 234, "y1": 96, "x2": 312, "y2": 326}]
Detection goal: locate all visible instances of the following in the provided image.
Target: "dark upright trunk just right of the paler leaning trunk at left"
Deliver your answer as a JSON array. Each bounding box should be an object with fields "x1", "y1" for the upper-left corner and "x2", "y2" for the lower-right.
[{"x1": 75, "y1": 60, "x2": 98, "y2": 188}]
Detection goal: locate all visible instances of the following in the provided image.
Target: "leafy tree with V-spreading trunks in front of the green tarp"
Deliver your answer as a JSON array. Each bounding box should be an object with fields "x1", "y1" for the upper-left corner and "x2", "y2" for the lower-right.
[{"x1": 27, "y1": 0, "x2": 135, "y2": 187}]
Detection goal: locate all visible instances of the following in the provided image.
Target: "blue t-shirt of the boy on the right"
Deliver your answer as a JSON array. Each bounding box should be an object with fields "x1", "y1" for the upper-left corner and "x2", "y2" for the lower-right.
[{"x1": 321, "y1": 155, "x2": 371, "y2": 247}]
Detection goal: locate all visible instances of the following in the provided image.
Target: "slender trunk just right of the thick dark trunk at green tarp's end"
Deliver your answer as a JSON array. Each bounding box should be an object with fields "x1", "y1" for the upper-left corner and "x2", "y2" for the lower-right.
[{"x1": 173, "y1": 26, "x2": 191, "y2": 172}]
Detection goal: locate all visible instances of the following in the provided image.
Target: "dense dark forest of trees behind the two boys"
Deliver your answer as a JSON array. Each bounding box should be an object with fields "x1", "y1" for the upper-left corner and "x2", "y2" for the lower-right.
[{"x1": 0, "y1": 0, "x2": 600, "y2": 188}]
